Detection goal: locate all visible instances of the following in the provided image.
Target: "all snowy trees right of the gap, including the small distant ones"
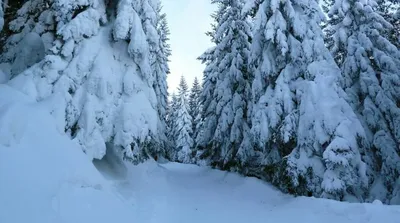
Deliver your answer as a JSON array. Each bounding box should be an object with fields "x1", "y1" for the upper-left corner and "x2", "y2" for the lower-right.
[{"x1": 167, "y1": 0, "x2": 400, "y2": 204}]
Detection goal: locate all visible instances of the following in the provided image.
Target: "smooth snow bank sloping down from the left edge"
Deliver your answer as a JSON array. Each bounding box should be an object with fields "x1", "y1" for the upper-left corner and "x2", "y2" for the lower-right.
[{"x1": 0, "y1": 85, "x2": 132, "y2": 223}]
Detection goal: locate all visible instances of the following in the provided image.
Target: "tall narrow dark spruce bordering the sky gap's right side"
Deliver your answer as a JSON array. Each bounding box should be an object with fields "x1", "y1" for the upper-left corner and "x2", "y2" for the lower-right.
[{"x1": 199, "y1": 0, "x2": 251, "y2": 169}]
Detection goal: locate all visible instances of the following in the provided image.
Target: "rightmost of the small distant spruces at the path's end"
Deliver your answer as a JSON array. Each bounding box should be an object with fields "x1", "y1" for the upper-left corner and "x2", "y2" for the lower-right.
[{"x1": 189, "y1": 77, "x2": 201, "y2": 139}]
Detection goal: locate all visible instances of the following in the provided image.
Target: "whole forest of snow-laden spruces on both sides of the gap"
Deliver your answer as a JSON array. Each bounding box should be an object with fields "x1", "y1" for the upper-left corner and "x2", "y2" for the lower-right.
[{"x1": 0, "y1": 0, "x2": 400, "y2": 205}]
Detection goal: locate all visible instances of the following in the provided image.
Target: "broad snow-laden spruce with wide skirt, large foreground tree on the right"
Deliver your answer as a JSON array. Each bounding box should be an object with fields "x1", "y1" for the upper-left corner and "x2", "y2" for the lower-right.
[{"x1": 248, "y1": 0, "x2": 366, "y2": 200}]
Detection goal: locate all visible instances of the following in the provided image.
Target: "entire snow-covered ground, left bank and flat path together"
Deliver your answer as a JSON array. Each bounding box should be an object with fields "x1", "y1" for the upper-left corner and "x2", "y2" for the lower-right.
[{"x1": 0, "y1": 85, "x2": 400, "y2": 223}]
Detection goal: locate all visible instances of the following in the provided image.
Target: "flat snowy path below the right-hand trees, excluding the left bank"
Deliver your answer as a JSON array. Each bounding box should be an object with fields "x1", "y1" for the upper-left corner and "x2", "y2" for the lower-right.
[{"x1": 105, "y1": 163, "x2": 400, "y2": 223}]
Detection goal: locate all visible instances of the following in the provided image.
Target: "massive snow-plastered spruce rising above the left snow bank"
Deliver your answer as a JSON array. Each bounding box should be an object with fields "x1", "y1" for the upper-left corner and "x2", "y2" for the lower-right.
[{"x1": 2, "y1": 0, "x2": 165, "y2": 162}]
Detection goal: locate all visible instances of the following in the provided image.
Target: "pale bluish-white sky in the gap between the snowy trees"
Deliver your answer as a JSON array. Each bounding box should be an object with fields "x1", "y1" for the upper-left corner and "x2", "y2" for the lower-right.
[{"x1": 162, "y1": 0, "x2": 216, "y2": 94}]
